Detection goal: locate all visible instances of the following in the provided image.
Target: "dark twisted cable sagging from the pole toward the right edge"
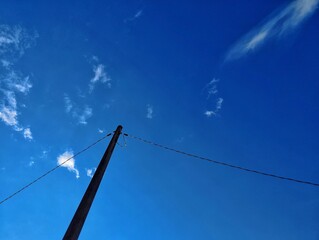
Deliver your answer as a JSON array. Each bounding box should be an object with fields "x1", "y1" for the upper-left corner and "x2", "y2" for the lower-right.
[{"x1": 124, "y1": 133, "x2": 319, "y2": 187}]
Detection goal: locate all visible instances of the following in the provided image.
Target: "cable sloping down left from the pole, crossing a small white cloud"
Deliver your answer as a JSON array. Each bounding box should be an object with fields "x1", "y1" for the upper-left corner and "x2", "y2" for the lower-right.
[{"x1": 0, "y1": 133, "x2": 112, "y2": 205}]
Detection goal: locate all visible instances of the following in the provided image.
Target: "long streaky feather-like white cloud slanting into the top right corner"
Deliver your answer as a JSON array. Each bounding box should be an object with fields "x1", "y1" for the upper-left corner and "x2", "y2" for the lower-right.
[{"x1": 225, "y1": 0, "x2": 319, "y2": 61}]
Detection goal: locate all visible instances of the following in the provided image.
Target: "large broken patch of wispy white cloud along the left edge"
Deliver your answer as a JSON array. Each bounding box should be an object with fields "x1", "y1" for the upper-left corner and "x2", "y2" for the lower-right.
[{"x1": 0, "y1": 25, "x2": 37, "y2": 140}]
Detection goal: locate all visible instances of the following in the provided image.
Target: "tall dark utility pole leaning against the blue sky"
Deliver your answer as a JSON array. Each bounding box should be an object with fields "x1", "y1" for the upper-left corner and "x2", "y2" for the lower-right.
[{"x1": 63, "y1": 125, "x2": 122, "y2": 240}]
